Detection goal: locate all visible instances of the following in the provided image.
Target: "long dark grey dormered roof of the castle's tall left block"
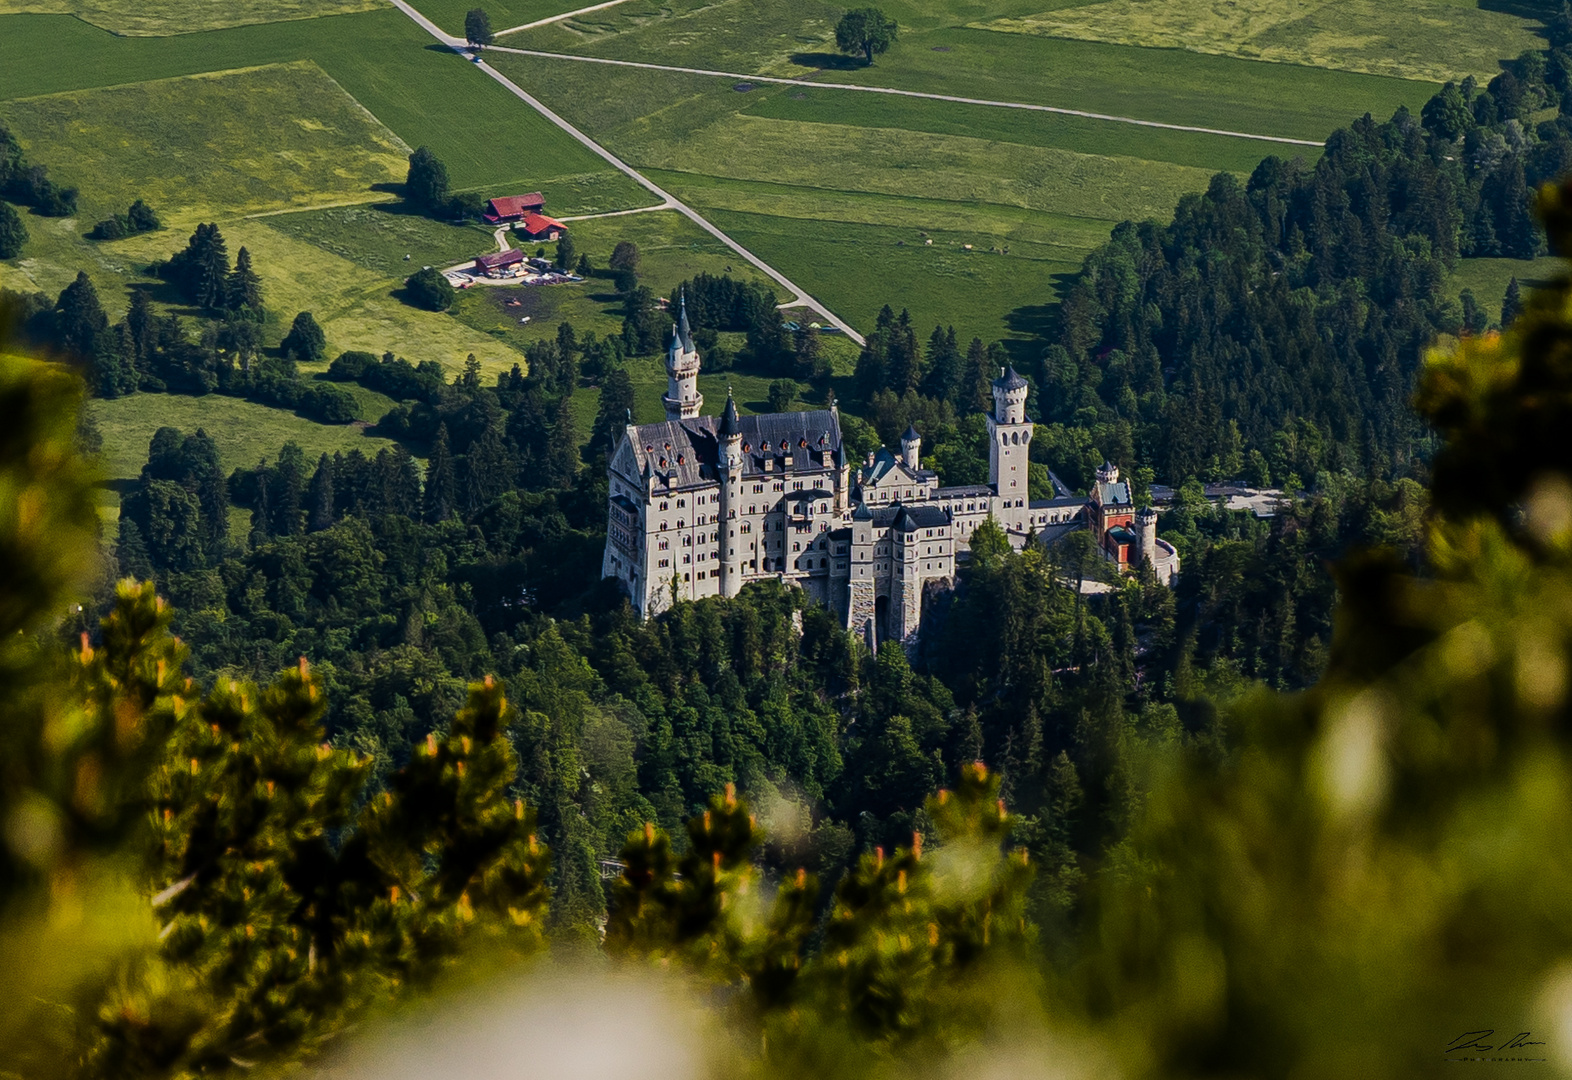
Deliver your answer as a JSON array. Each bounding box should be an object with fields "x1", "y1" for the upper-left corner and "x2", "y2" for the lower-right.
[{"x1": 629, "y1": 406, "x2": 841, "y2": 487}]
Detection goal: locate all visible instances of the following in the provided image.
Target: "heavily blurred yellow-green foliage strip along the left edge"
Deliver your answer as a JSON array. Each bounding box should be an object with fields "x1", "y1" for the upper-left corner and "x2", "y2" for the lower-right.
[{"x1": 0, "y1": 354, "x2": 160, "y2": 1075}]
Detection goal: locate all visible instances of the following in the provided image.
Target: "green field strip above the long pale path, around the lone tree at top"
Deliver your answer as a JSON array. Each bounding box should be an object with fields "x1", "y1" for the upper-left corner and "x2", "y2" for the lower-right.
[{"x1": 505, "y1": 0, "x2": 1439, "y2": 141}]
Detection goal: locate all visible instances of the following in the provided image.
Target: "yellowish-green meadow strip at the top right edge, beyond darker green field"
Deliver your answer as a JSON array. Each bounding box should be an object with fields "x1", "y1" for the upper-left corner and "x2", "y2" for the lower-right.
[{"x1": 973, "y1": 0, "x2": 1542, "y2": 82}]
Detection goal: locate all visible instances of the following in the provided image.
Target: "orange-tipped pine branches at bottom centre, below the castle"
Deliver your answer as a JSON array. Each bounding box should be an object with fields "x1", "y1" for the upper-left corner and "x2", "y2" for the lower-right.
[{"x1": 607, "y1": 764, "x2": 1034, "y2": 1072}]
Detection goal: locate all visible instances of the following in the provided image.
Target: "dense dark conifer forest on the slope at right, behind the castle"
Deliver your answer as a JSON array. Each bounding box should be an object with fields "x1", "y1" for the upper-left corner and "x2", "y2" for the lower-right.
[{"x1": 1036, "y1": 19, "x2": 1572, "y2": 483}]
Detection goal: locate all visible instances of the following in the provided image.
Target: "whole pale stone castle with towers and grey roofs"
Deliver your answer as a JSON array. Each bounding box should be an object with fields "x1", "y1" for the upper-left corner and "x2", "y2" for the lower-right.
[{"x1": 601, "y1": 303, "x2": 1179, "y2": 643}]
